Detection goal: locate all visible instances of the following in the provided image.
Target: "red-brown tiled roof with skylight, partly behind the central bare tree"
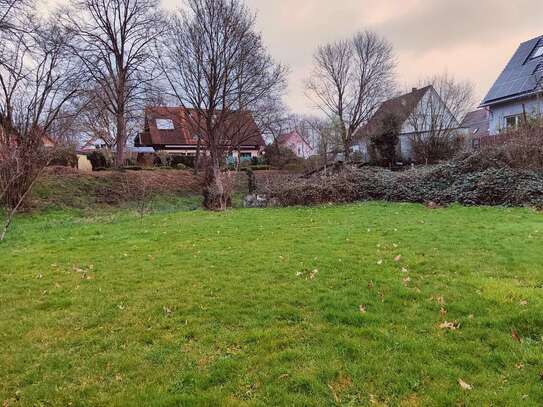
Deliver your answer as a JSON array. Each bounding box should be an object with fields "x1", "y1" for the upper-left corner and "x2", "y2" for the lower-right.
[{"x1": 136, "y1": 106, "x2": 265, "y2": 147}]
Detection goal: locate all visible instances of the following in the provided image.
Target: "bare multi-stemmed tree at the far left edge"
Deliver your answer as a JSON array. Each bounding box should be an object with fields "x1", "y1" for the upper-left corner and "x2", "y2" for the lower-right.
[{"x1": 0, "y1": 8, "x2": 78, "y2": 240}]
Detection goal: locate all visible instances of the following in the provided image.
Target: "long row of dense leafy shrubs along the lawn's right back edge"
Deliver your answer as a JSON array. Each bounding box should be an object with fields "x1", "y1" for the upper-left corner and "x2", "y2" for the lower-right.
[{"x1": 265, "y1": 153, "x2": 543, "y2": 207}]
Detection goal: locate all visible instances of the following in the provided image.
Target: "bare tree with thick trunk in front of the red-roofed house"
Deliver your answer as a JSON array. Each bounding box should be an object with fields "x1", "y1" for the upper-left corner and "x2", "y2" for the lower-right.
[{"x1": 162, "y1": 0, "x2": 286, "y2": 210}]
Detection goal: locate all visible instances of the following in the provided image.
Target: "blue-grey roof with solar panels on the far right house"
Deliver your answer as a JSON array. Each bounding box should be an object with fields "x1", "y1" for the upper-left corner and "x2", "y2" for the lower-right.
[{"x1": 481, "y1": 36, "x2": 543, "y2": 106}]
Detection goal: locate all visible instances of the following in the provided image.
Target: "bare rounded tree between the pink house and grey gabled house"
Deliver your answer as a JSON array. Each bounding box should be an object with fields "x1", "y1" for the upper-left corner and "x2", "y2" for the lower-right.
[{"x1": 306, "y1": 31, "x2": 396, "y2": 160}]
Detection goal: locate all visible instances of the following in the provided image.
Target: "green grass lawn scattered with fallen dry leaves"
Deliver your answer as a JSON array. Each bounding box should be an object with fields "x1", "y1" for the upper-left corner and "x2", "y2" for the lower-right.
[{"x1": 0, "y1": 203, "x2": 543, "y2": 406}]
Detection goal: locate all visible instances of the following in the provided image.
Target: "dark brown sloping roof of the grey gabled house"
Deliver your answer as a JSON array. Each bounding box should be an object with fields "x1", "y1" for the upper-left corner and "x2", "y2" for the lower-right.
[{"x1": 355, "y1": 85, "x2": 432, "y2": 138}]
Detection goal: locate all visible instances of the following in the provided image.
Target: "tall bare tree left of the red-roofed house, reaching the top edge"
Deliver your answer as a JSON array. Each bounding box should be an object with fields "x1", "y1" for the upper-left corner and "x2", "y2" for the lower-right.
[{"x1": 64, "y1": 0, "x2": 164, "y2": 166}]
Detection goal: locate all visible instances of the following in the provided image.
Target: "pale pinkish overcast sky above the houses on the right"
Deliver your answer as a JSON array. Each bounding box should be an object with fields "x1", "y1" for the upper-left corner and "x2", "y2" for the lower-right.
[{"x1": 44, "y1": 0, "x2": 543, "y2": 113}]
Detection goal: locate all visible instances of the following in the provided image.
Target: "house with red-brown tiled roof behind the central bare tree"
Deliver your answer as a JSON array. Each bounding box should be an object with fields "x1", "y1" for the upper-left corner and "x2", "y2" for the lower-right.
[{"x1": 134, "y1": 106, "x2": 265, "y2": 160}]
